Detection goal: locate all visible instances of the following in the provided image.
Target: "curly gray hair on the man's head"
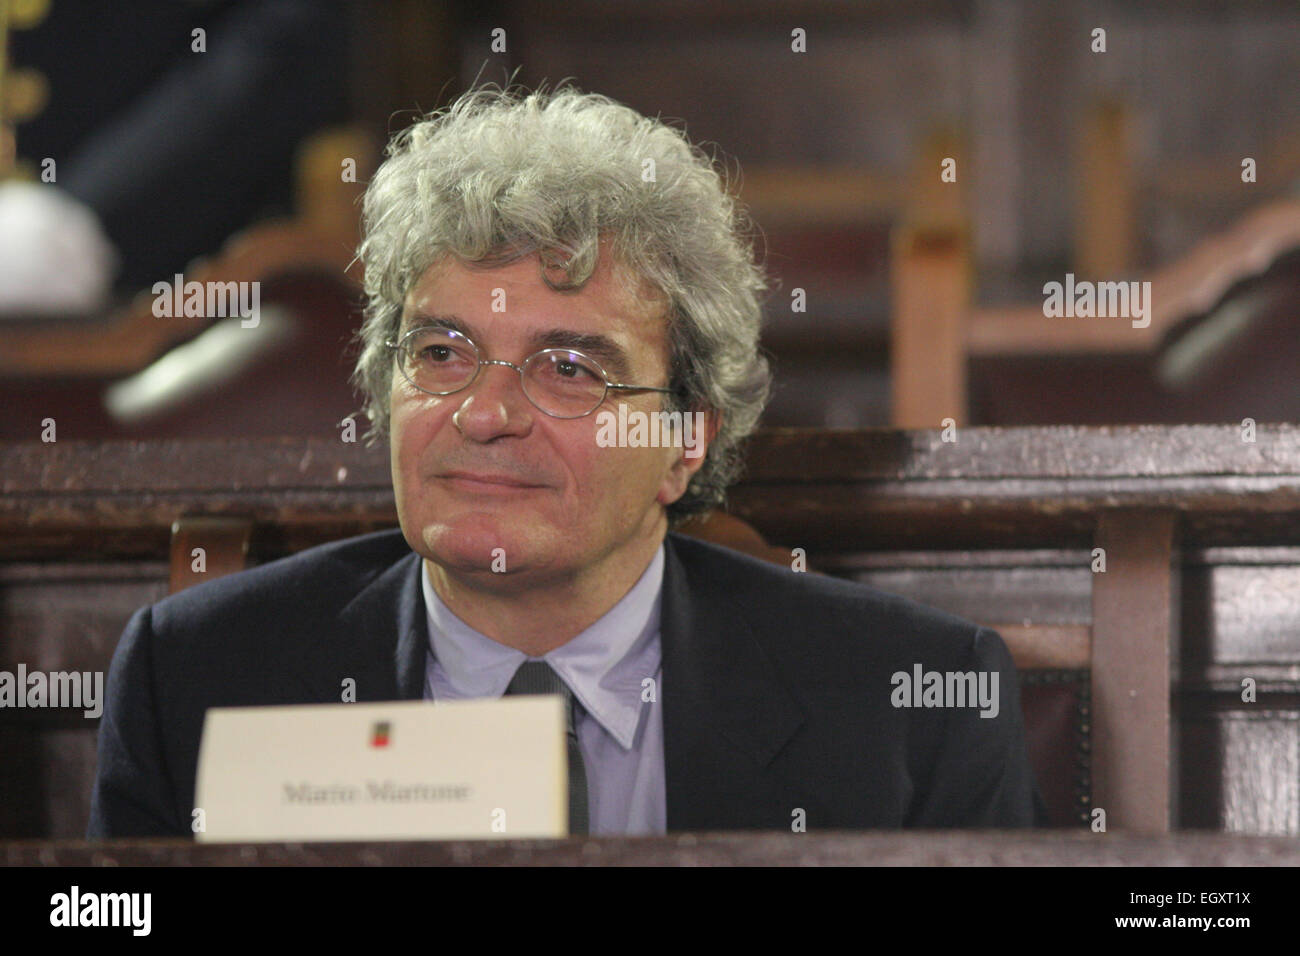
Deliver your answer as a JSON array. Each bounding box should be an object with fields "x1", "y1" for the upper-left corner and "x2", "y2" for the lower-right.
[{"x1": 352, "y1": 85, "x2": 771, "y2": 525}]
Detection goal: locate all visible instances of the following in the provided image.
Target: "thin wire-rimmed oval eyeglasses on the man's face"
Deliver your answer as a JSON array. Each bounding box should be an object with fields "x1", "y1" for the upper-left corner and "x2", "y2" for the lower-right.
[{"x1": 384, "y1": 325, "x2": 672, "y2": 419}]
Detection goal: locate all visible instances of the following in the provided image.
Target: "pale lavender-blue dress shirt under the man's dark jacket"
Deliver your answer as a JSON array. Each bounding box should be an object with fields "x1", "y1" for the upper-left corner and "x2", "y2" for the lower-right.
[{"x1": 420, "y1": 545, "x2": 667, "y2": 835}]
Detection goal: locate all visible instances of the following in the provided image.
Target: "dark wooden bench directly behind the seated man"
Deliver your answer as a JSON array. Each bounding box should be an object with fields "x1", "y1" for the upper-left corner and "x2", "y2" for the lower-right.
[{"x1": 0, "y1": 425, "x2": 1300, "y2": 836}]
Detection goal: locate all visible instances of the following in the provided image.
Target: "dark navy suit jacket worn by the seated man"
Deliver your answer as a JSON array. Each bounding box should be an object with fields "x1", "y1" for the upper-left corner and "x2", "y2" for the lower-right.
[{"x1": 88, "y1": 531, "x2": 1045, "y2": 838}]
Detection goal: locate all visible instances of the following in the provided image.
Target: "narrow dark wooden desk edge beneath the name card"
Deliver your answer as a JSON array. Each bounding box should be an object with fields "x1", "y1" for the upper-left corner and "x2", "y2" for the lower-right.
[{"x1": 0, "y1": 830, "x2": 1300, "y2": 866}]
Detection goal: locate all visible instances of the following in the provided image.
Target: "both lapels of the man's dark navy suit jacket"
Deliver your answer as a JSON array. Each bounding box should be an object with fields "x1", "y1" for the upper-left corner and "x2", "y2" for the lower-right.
[{"x1": 299, "y1": 535, "x2": 803, "y2": 830}]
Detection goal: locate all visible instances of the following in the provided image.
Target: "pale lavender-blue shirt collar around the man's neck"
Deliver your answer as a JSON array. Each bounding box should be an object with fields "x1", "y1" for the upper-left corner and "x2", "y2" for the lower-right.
[{"x1": 420, "y1": 544, "x2": 664, "y2": 749}]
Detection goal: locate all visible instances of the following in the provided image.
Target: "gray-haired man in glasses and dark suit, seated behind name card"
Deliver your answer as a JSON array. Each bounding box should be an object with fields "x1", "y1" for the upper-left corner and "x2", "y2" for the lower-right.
[{"x1": 90, "y1": 88, "x2": 1040, "y2": 836}]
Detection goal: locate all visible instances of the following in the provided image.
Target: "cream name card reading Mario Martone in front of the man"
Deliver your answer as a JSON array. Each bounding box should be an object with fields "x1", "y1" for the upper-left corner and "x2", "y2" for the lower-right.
[{"x1": 195, "y1": 696, "x2": 568, "y2": 843}]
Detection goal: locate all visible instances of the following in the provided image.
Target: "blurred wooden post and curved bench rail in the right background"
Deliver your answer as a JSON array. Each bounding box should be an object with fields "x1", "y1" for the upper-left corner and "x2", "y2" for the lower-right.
[{"x1": 891, "y1": 199, "x2": 1300, "y2": 428}]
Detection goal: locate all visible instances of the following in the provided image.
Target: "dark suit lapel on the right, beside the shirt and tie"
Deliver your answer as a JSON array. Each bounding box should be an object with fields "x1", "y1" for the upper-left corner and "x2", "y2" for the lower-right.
[{"x1": 660, "y1": 535, "x2": 803, "y2": 830}]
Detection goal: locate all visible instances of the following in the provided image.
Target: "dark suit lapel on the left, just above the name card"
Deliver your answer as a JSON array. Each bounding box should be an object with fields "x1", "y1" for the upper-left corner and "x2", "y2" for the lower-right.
[{"x1": 308, "y1": 553, "x2": 429, "y2": 701}]
